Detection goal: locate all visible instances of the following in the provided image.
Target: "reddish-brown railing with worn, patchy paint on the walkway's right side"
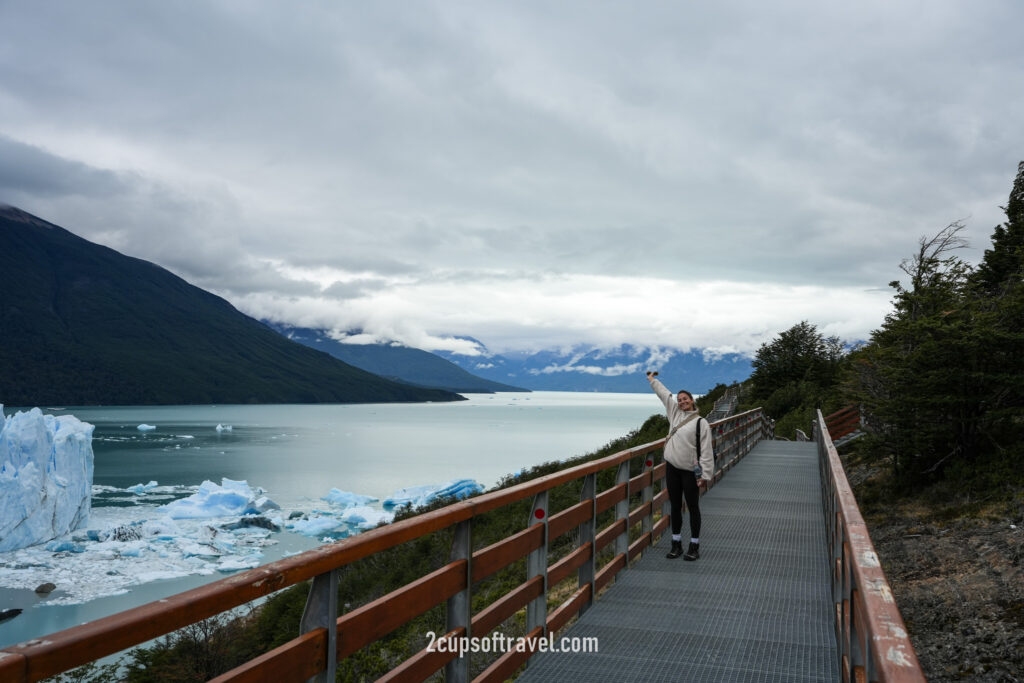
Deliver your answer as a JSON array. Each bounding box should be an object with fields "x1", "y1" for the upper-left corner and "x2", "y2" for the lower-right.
[{"x1": 814, "y1": 411, "x2": 925, "y2": 683}]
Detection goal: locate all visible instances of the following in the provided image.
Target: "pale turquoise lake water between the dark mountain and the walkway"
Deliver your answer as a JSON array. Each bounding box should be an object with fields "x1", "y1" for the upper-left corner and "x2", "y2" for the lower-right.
[{"x1": 0, "y1": 391, "x2": 662, "y2": 646}]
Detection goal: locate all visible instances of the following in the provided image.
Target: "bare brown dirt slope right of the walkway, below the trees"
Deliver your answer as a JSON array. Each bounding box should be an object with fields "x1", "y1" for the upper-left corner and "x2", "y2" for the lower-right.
[{"x1": 847, "y1": 456, "x2": 1024, "y2": 683}]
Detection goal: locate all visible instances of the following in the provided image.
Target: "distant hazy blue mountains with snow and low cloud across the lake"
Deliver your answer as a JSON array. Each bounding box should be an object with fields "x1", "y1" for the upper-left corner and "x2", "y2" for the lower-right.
[{"x1": 438, "y1": 340, "x2": 752, "y2": 393}]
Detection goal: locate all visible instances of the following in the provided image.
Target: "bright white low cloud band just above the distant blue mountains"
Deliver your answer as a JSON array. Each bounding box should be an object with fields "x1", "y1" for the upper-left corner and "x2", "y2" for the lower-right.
[{"x1": 228, "y1": 272, "x2": 891, "y2": 362}]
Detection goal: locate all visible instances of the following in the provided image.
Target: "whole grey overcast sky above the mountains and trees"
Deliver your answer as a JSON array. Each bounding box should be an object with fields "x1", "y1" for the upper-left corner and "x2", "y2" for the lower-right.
[{"x1": 0, "y1": 0, "x2": 1024, "y2": 352}]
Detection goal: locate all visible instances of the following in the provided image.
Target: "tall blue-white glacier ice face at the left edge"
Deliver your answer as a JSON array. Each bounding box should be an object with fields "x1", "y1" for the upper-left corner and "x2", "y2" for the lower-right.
[{"x1": 0, "y1": 404, "x2": 93, "y2": 552}]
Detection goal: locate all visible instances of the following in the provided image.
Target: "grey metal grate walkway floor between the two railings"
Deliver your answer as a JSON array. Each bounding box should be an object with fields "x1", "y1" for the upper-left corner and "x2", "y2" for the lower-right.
[{"x1": 518, "y1": 441, "x2": 839, "y2": 683}]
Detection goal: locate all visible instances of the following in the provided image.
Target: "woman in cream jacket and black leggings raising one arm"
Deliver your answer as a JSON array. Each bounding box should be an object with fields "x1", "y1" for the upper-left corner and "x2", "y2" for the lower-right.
[{"x1": 647, "y1": 372, "x2": 715, "y2": 560}]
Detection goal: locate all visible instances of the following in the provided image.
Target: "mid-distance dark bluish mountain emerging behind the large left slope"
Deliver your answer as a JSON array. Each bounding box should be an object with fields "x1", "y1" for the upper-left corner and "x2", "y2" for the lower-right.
[{"x1": 264, "y1": 321, "x2": 528, "y2": 393}]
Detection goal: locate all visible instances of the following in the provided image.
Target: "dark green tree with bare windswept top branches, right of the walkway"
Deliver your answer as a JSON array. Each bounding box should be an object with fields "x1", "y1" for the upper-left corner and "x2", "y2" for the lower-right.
[{"x1": 853, "y1": 222, "x2": 980, "y2": 481}]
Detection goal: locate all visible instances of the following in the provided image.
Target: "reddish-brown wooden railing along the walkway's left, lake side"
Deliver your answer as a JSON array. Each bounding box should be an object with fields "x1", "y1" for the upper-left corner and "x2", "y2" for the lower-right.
[{"x1": 0, "y1": 410, "x2": 772, "y2": 683}]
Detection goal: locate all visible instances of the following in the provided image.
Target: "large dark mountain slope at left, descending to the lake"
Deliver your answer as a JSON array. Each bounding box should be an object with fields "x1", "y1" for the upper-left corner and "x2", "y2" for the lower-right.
[{"x1": 0, "y1": 206, "x2": 462, "y2": 405}]
